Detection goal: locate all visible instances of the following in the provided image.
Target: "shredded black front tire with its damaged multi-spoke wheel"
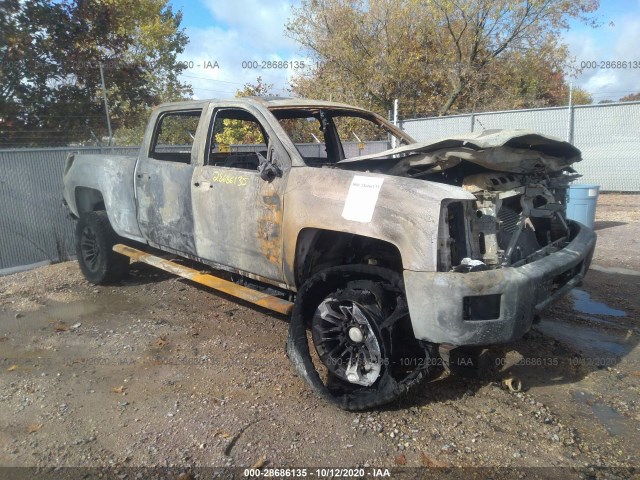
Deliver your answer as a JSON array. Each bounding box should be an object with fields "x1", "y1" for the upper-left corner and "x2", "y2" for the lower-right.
[{"x1": 287, "y1": 265, "x2": 432, "y2": 410}]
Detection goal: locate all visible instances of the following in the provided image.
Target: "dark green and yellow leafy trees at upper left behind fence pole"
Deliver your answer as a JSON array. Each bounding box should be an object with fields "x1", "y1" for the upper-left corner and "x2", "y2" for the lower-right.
[{"x1": 0, "y1": 0, "x2": 191, "y2": 146}]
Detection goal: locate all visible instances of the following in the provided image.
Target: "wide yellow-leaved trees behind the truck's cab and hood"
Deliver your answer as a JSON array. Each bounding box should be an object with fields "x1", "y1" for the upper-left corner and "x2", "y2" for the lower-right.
[{"x1": 287, "y1": 0, "x2": 598, "y2": 115}]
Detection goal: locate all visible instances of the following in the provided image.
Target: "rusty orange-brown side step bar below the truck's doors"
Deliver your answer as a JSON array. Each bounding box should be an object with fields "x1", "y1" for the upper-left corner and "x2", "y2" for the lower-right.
[{"x1": 113, "y1": 243, "x2": 293, "y2": 315}]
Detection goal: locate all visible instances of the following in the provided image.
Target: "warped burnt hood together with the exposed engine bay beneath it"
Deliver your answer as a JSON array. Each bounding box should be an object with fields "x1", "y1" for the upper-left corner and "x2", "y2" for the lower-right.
[{"x1": 337, "y1": 130, "x2": 580, "y2": 272}]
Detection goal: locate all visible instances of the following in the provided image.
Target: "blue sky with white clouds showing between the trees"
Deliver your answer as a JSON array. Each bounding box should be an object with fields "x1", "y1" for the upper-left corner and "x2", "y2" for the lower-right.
[{"x1": 171, "y1": 0, "x2": 640, "y2": 103}]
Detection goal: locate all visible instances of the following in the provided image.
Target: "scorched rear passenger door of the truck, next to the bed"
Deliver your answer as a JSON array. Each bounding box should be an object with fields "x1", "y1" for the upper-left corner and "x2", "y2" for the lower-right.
[{"x1": 135, "y1": 109, "x2": 206, "y2": 254}]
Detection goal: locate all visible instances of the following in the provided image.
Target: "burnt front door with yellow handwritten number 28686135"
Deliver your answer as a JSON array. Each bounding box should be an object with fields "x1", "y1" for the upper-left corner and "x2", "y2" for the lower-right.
[{"x1": 192, "y1": 108, "x2": 290, "y2": 281}]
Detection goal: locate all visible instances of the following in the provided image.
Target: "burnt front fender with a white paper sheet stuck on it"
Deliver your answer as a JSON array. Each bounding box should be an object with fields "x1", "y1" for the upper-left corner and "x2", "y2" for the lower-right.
[{"x1": 283, "y1": 167, "x2": 475, "y2": 284}]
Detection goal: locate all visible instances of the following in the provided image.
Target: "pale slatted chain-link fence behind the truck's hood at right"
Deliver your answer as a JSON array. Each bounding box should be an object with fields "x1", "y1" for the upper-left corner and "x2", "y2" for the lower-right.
[{"x1": 399, "y1": 102, "x2": 640, "y2": 192}]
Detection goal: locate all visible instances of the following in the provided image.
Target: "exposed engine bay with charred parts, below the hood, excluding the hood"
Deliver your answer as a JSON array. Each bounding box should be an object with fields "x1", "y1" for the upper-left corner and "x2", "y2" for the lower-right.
[{"x1": 438, "y1": 171, "x2": 577, "y2": 272}]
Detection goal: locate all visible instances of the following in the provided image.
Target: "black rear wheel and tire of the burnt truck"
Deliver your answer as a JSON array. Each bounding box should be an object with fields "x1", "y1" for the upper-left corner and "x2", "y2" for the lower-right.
[{"x1": 76, "y1": 210, "x2": 129, "y2": 285}]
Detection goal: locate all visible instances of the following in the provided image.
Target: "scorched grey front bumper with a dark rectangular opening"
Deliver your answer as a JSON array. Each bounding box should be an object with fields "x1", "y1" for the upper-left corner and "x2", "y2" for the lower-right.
[{"x1": 404, "y1": 221, "x2": 596, "y2": 345}]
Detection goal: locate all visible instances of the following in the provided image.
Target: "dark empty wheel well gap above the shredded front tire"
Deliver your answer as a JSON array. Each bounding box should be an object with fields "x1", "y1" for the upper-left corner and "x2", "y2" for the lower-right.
[{"x1": 294, "y1": 228, "x2": 402, "y2": 286}]
